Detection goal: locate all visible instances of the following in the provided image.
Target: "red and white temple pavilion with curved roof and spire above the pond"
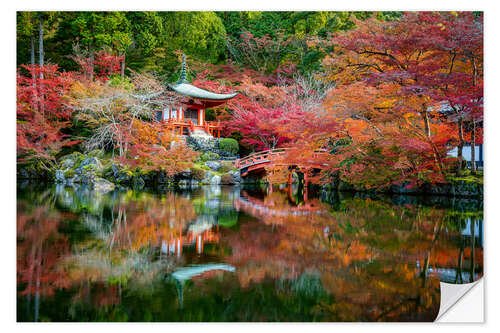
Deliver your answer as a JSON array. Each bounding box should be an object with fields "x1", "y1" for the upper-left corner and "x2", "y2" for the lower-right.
[{"x1": 153, "y1": 55, "x2": 238, "y2": 138}]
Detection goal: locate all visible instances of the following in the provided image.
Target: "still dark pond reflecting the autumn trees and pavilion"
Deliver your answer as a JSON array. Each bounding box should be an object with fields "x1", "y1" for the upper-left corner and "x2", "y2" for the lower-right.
[{"x1": 17, "y1": 184, "x2": 483, "y2": 322}]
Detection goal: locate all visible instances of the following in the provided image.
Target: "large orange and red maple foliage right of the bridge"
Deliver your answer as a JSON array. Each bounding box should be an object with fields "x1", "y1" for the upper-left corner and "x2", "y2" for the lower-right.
[{"x1": 310, "y1": 12, "x2": 483, "y2": 186}]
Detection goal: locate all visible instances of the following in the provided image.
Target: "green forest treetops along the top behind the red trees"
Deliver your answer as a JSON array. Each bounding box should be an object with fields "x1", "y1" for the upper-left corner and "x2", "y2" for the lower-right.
[{"x1": 17, "y1": 11, "x2": 402, "y2": 74}]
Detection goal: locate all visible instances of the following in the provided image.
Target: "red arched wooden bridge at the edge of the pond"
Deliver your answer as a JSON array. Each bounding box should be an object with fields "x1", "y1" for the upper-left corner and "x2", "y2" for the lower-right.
[{"x1": 235, "y1": 148, "x2": 327, "y2": 177}]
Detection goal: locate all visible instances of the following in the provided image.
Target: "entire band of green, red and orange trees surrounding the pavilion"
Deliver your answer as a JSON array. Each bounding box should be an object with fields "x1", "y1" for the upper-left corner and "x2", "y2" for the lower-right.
[{"x1": 17, "y1": 11, "x2": 483, "y2": 187}]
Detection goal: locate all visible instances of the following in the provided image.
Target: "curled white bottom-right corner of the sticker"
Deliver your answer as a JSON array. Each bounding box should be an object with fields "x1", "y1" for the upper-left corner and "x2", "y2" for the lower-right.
[{"x1": 435, "y1": 278, "x2": 484, "y2": 323}]
